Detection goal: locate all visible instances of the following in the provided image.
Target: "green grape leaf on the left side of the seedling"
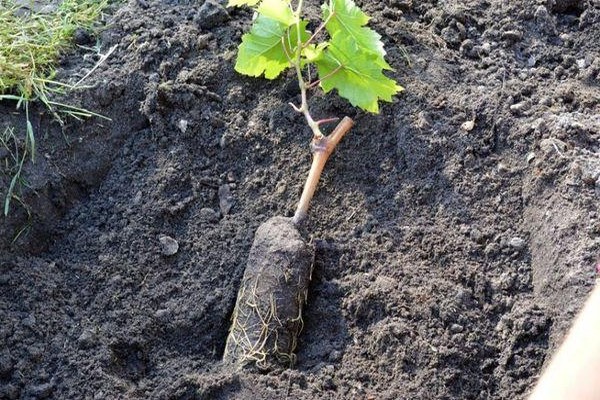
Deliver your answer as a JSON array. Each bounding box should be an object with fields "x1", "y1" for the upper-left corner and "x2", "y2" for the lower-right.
[{"x1": 235, "y1": 15, "x2": 310, "y2": 79}]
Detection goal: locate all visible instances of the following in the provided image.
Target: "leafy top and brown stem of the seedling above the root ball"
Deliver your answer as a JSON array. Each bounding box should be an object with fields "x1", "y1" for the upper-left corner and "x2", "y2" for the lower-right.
[{"x1": 228, "y1": 0, "x2": 403, "y2": 223}]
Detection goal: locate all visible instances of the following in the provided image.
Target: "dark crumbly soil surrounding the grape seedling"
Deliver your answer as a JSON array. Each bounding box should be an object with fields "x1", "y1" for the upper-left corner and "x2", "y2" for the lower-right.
[{"x1": 0, "y1": 0, "x2": 600, "y2": 399}]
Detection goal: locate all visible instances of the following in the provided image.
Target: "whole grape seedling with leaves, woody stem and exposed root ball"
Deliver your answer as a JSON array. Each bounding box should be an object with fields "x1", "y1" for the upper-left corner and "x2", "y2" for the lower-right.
[{"x1": 223, "y1": 0, "x2": 402, "y2": 368}]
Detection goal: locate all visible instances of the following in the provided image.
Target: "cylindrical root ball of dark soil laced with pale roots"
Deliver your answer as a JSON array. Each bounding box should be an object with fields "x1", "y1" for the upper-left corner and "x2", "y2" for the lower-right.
[{"x1": 223, "y1": 217, "x2": 313, "y2": 369}]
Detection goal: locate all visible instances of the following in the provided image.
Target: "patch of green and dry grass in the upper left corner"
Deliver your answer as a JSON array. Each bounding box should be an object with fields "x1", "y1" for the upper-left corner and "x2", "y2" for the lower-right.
[{"x1": 0, "y1": 0, "x2": 109, "y2": 215}]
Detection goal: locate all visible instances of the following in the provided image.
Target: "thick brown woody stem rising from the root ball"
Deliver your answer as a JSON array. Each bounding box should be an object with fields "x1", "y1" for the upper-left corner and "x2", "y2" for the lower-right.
[{"x1": 293, "y1": 117, "x2": 354, "y2": 224}]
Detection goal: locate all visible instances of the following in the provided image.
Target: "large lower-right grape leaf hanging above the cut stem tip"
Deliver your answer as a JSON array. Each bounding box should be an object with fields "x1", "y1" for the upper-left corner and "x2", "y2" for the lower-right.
[{"x1": 315, "y1": 32, "x2": 403, "y2": 113}]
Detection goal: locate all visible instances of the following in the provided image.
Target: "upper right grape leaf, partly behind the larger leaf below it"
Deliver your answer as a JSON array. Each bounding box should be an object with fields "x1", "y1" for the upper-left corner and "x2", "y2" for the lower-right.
[{"x1": 322, "y1": 0, "x2": 392, "y2": 70}]
